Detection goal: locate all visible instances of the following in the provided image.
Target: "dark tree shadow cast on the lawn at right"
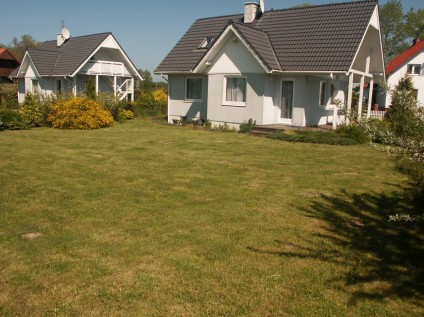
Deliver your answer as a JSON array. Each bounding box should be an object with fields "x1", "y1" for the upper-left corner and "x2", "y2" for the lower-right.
[{"x1": 249, "y1": 190, "x2": 424, "y2": 305}]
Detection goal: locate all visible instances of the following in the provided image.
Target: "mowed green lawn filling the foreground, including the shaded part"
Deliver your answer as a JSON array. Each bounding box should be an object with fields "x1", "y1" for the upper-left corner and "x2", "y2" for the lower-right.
[{"x1": 0, "y1": 120, "x2": 424, "y2": 316}]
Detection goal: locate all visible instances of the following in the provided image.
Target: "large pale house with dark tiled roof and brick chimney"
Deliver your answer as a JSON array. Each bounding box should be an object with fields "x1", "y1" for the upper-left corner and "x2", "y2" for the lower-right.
[{"x1": 155, "y1": 0, "x2": 384, "y2": 127}]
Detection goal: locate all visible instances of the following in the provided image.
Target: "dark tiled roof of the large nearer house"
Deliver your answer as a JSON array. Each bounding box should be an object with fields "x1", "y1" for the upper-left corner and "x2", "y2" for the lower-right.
[{"x1": 155, "y1": 0, "x2": 377, "y2": 73}]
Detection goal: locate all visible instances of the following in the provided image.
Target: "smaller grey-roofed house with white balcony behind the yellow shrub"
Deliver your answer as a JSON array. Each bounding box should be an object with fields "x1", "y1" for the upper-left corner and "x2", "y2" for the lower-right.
[{"x1": 10, "y1": 29, "x2": 143, "y2": 102}]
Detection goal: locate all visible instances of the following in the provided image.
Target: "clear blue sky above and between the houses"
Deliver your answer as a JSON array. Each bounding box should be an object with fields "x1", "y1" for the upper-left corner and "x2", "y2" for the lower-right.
[{"x1": 0, "y1": 0, "x2": 424, "y2": 80}]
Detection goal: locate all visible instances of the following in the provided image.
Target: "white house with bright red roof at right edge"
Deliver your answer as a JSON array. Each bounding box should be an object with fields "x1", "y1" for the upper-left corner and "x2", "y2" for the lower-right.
[{"x1": 378, "y1": 39, "x2": 424, "y2": 108}]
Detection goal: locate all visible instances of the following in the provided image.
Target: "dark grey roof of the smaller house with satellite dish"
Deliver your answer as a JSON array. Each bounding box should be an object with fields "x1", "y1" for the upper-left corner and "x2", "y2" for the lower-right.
[{"x1": 28, "y1": 32, "x2": 112, "y2": 76}]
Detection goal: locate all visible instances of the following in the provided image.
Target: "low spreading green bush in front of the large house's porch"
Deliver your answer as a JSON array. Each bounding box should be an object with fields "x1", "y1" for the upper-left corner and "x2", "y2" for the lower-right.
[{"x1": 268, "y1": 131, "x2": 358, "y2": 145}]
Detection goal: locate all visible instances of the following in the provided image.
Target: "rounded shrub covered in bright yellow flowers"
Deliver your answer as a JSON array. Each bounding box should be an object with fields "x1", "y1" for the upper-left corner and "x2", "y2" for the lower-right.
[{"x1": 48, "y1": 98, "x2": 114, "y2": 130}]
